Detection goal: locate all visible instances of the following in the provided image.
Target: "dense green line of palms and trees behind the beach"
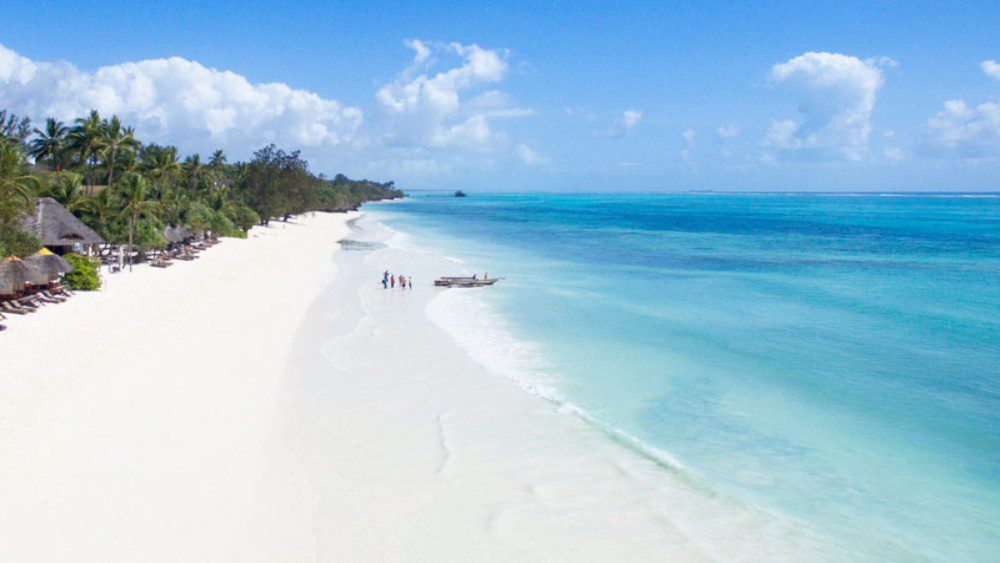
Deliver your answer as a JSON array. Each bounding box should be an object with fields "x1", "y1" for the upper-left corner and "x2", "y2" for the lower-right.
[{"x1": 0, "y1": 110, "x2": 403, "y2": 256}]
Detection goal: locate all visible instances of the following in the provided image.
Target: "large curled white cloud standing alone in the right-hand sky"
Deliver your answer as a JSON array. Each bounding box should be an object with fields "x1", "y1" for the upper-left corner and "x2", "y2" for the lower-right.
[{"x1": 765, "y1": 52, "x2": 894, "y2": 159}]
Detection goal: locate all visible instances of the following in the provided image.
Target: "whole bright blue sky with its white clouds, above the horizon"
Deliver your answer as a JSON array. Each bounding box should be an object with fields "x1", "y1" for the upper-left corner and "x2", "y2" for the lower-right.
[{"x1": 0, "y1": 0, "x2": 1000, "y2": 190}]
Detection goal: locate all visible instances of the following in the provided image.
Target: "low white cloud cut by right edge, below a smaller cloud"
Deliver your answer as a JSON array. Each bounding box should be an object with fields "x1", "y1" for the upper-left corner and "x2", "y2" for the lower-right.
[{"x1": 927, "y1": 100, "x2": 1000, "y2": 159}]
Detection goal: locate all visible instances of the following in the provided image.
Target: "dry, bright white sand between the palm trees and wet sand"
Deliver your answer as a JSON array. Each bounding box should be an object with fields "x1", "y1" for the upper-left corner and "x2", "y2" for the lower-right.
[{"x1": 0, "y1": 215, "x2": 346, "y2": 561}]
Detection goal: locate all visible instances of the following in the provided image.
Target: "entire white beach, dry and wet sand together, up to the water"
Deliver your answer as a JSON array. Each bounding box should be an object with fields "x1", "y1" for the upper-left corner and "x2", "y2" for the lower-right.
[{"x1": 0, "y1": 210, "x2": 816, "y2": 561}]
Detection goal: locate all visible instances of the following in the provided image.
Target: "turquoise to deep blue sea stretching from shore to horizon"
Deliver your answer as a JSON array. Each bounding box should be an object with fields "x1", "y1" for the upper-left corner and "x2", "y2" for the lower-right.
[{"x1": 373, "y1": 192, "x2": 1000, "y2": 560}]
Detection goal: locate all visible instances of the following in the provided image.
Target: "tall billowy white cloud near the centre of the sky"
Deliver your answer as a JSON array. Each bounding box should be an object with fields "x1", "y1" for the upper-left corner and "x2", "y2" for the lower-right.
[{"x1": 376, "y1": 40, "x2": 533, "y2": 151}]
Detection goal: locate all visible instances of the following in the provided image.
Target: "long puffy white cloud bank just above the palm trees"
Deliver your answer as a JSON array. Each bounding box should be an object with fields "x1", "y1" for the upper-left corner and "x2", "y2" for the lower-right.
[{"x1": 0, "y1": 45, "x2": 363, "y2": 156}]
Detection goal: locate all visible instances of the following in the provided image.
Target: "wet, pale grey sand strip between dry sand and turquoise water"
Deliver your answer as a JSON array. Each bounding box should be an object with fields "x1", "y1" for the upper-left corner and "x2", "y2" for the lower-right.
[{"x1": 284, "y1": 213, "x2": 820, "y2": 560}]
